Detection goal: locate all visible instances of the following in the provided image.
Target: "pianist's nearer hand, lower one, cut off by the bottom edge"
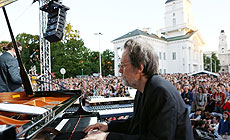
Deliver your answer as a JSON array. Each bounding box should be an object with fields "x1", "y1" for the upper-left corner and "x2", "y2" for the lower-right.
[{"x1": 82, "y1": 131, "x2": 109, "y2": 140}]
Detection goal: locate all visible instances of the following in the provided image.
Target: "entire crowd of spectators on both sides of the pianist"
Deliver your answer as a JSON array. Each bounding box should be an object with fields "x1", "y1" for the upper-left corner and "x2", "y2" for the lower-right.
[{"x1": 31, "y1": 73, "x2": 230, "y2": 138}]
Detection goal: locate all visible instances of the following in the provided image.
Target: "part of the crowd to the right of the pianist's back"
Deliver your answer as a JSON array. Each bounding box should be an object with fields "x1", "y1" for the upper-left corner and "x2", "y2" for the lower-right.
[{"x1": 162, "y1": 73, "x2": 230, "y2": 139}]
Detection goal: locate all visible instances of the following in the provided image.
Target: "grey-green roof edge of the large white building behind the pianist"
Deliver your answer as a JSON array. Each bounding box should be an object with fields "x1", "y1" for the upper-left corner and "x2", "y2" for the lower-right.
[{"x1": 113, "y1": 29, "x2": 195, "y2": 42}]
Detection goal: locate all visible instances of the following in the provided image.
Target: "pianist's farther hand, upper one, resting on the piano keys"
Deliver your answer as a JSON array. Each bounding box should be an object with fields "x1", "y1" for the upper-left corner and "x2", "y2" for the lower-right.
[{"x1": 82, "y1": 123, "x2": 108, "y2": 133}]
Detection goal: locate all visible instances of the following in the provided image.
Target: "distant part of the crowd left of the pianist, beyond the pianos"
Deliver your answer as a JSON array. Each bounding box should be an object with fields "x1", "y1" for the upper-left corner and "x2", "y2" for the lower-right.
[{"x1": 34, "y1": 76, "x2": 132, "y2": 97}]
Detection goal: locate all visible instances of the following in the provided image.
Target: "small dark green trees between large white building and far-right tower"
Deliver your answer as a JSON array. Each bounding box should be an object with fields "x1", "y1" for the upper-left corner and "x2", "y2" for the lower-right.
[{"x1": 203, "y1": 52, "x2": 220, "y2": 72}]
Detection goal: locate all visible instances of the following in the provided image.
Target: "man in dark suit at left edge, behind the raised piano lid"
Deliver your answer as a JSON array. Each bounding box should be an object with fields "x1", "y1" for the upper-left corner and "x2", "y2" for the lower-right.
[{"x1": 0, "y1": 42, "x2": 23, "y2": 92}]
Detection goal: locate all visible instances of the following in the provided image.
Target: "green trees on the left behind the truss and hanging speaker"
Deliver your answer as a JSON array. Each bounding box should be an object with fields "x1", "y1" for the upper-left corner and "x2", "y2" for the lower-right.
[{"x1": 0, "y1": 24, "x2": 114, "y2": 78}]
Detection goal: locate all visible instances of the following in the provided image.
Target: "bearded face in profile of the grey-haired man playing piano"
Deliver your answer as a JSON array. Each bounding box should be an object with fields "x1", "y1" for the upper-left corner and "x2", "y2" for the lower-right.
[{"x1": 119, "y1": 50, "x2": 138, "y2": 88}]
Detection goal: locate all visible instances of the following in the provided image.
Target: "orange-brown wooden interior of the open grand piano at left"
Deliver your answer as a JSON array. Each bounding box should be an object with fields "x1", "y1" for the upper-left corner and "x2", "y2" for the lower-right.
[{"x1": 0, "y1": 91, "x2": 80, "y2": 127}]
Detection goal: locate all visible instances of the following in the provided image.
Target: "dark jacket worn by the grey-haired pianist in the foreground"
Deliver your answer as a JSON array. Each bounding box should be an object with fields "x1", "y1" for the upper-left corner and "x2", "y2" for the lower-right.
[{"x1": 107, "y1": 75, "x2": 194, "y2": 140}]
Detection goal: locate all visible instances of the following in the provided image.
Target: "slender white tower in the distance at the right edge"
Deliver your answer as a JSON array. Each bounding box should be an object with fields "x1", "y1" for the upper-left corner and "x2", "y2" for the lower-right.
[{"x1": 217, "y1": 30, "x2": 230, "y2": 73}]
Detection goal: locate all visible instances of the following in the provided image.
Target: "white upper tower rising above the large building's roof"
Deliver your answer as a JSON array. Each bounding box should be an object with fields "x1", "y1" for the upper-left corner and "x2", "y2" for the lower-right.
[{"x1": 161, "y1": 0, "x2": 196, "y2": 38}]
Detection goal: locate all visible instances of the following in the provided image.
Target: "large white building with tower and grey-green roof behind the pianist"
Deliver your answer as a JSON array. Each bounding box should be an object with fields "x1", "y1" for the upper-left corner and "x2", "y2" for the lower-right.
[{"x1": 112, "y1": 0, "x2": 205, "y2": 76}]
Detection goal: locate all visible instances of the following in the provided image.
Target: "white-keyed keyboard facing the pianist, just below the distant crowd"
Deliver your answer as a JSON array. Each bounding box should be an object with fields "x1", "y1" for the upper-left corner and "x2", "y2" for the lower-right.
[{"x1": 83, "y1": 103, "x2": 133, "y2": 118}]
